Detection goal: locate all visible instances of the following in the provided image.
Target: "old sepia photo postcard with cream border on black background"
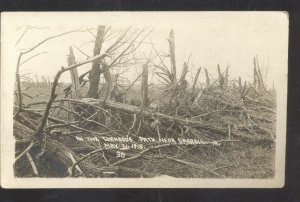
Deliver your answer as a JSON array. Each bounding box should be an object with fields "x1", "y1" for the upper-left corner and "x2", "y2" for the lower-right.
[{"x1": 1, "y1": 12, "x2": 288, "y2": 188}]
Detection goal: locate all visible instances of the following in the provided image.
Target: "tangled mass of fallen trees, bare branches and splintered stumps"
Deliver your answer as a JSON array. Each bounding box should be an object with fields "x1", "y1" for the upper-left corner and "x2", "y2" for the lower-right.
[{"x1": 14, "y1": 27, "x2": 276, "y2": 178}]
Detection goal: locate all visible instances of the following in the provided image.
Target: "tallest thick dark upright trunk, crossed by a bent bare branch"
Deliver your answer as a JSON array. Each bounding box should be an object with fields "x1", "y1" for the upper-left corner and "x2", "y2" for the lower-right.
[{"x1": 87, "y1": 25, "x2": 105, "y2": 98}]
